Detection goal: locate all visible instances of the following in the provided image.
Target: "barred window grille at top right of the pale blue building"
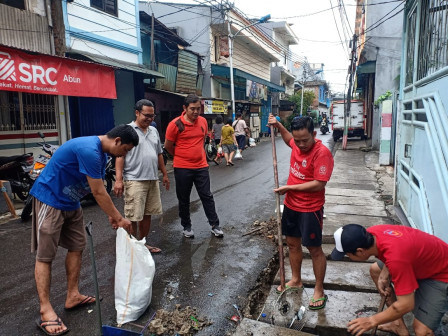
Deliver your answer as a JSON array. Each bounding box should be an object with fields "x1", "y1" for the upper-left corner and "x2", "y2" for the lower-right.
[{"x1": 417, "y1": 0, "x2": 448, "y2": 80}]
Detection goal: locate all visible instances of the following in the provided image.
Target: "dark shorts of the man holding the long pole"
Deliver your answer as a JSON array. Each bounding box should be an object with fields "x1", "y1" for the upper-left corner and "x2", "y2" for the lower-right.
[{"x1": 282, "y1": 205, "x2": 324, "y2": 246}]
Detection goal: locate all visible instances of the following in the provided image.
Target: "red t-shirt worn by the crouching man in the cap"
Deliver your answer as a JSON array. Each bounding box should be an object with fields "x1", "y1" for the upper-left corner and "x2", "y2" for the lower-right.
[{"x1": 367, "y1": 225, "x2": 448, "y2": 295}]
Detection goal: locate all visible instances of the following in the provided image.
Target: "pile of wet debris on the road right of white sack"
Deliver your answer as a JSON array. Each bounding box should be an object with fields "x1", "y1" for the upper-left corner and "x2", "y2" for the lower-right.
[{"x1": 148, "y1": 304, "x2": 212, "y2": 335}]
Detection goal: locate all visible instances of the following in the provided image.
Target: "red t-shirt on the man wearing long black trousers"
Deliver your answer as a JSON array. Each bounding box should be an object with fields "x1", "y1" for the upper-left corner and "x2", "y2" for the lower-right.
[{"x1": 165, "y1": 111, "x2": 208, "y2": 169}]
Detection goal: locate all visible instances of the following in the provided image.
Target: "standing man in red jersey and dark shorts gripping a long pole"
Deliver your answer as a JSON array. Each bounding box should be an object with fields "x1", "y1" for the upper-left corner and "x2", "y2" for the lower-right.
[{"x1": 269, "y1": 115, "x2": 334, "y2": 310}]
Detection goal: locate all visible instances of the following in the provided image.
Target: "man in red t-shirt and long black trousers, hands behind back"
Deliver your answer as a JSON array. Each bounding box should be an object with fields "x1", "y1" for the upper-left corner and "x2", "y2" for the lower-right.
[{"x1": 165, "y1": 94, "x2": 224, "y2": 238}]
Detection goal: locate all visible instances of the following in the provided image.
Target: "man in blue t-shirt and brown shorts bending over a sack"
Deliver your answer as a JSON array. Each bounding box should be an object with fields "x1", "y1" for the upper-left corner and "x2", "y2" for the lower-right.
[{"x1": 30, "y1": 125, "x2": 138, "y2": 335}]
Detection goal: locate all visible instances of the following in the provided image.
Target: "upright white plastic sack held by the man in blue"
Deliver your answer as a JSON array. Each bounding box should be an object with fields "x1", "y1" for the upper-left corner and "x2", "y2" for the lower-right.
[{"x1": 115, "y1": 228, "x2": 156, "y2": 325}]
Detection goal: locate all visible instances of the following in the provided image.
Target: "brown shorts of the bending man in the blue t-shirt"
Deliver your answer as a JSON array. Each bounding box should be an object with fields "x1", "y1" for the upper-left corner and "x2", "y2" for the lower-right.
[{"x1": 31, "y1": 198, "x2": 86, "y2": 262}]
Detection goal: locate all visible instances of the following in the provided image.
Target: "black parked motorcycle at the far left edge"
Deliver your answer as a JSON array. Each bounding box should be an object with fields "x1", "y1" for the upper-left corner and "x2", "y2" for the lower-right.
[{"x1": 0, "y1": 153, "x2": 34, "y2": 201}]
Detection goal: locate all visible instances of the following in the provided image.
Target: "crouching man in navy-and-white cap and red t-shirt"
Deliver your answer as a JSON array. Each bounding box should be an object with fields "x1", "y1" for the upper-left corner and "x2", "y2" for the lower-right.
[{"x1": 331, "y1": 224, "x2": 448, "y2": 336}]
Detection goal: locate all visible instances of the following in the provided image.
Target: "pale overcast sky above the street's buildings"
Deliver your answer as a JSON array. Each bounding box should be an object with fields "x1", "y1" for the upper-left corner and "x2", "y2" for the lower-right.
[{"x1": 150, "y1": 0, "x2": 356, "y2": 92}]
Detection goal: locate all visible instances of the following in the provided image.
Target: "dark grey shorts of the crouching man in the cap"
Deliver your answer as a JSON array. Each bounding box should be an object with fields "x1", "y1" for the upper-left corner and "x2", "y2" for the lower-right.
[{"x1": 377, "y1": 260, "x2": 448, "y2": 331}]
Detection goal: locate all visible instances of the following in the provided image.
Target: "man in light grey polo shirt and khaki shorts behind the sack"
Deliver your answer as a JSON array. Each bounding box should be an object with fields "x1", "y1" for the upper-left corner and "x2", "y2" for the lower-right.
[{"x1": 114, "y1": 99, "x2": 170, "y2": 253}]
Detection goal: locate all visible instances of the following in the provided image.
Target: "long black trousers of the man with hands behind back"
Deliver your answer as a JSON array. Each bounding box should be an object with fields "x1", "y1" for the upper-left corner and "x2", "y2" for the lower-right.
[{"x1": 174, "y1": 167, "x2": 219, "y2": 228}]
